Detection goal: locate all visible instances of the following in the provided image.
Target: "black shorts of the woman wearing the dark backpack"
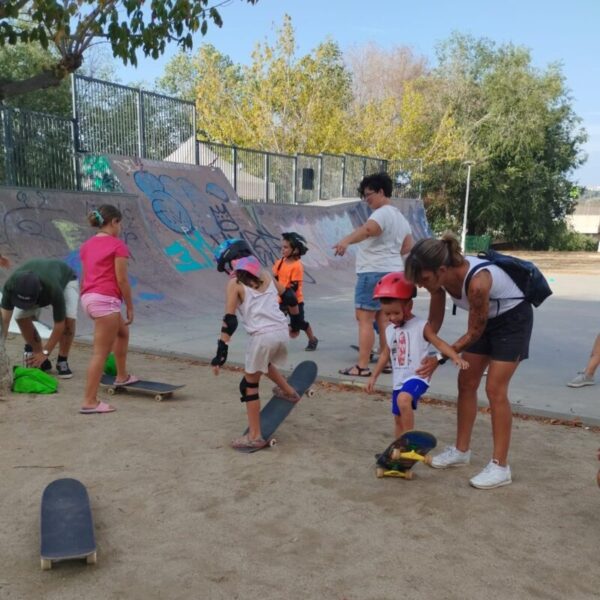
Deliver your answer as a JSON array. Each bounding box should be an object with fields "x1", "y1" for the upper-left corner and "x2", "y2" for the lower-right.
[{"x1": 464, "y1": 302, "x2": 533, "y2": 362}]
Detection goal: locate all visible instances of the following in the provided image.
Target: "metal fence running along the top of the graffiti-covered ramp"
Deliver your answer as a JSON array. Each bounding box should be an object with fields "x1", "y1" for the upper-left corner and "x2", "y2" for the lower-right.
[{"x1": 0, "y1": 75, "x2": 422, "y2": 204}]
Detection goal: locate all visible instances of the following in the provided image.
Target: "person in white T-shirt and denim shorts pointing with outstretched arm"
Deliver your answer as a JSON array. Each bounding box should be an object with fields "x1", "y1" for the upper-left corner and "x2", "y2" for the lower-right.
[{"x1": 333, "y1": 173, "x2": 413, "y2": 377}]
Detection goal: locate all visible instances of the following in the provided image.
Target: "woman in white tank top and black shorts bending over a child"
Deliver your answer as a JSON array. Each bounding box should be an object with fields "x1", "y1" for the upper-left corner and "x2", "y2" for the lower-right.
[{"x1": 405, "y1": 234, "x2": 533, "y2": 489}]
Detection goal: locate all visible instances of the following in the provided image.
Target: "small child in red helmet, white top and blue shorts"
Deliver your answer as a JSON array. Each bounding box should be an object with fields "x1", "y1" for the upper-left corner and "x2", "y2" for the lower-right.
[{"x1": 365, "y1": 273, "x2": 469, "y2": 438}]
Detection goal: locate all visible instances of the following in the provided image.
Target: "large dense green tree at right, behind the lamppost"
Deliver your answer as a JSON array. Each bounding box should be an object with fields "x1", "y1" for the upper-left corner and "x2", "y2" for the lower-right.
[{"x1": 418, "y1": 35, "x2": 586, "y2": 250}]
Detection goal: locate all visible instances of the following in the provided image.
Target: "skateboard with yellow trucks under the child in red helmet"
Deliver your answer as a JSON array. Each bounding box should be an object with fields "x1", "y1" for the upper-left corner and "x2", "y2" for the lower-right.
[{"x1": 375, "y1": 431, "x2": 437, "y2": 479}]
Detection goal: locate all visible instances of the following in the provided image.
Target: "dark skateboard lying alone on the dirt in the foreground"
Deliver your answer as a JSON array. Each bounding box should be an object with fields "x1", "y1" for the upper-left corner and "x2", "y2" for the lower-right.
[{"x1": 40, "y1": 479, "x2": 96, "y2": 571}]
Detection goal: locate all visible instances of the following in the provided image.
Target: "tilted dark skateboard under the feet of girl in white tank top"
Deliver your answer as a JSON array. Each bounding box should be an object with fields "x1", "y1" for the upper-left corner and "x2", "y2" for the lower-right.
[{"x1": 239, "y1": 360, "x2": 318, "y2": 454}]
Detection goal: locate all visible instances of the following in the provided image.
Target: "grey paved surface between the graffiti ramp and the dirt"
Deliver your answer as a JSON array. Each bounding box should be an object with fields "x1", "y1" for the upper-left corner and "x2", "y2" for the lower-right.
[{"x1": 119, "y1": 274, "x2": 600, "y2": 425}]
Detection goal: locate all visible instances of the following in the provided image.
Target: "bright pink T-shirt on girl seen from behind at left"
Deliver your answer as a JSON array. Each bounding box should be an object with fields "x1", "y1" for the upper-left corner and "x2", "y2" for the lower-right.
[{"x1": 79, "y1": 235, "x2": 129, "y2": 300}]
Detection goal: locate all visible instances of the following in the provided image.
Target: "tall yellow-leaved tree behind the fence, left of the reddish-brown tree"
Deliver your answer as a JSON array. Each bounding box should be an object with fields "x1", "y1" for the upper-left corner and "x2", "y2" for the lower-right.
[{"x1": 159, "y1": 17, "x2": 351, "y2": 154}]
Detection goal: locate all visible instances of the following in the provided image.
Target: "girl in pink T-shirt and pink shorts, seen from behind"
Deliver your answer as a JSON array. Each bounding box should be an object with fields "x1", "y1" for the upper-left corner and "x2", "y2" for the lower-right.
[{"x1": 79, "y1": 204, "x2": 139, "y2": 414}]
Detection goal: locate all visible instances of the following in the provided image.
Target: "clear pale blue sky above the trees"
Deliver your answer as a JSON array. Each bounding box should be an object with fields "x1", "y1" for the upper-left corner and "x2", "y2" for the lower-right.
[{"x1": 117, "y1": 0, "x2": 600, "y2": 187}]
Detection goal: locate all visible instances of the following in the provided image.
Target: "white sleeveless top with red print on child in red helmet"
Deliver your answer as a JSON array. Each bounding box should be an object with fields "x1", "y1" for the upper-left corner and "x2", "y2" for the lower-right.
[{"x1": 385, "y1": 317, "x2": 431, "y2": 390}]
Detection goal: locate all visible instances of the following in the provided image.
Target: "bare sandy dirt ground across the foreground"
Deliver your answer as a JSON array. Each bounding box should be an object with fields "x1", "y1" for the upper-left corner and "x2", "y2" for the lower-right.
[{"x1": 0, "y1": 338, "x2": 600, "y2": 600}]
